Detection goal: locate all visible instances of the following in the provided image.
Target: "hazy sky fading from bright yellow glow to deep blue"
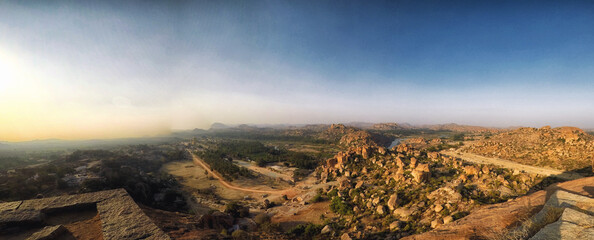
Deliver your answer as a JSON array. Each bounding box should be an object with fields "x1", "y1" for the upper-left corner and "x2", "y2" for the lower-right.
[{"x1": 0, "y1": 0, "x2": 594, "y2": 141}]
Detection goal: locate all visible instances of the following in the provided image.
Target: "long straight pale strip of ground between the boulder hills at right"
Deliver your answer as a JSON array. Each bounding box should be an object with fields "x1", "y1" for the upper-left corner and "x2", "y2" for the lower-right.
[{"x1": 441, "y1": 150, "x2": 583, "y2": 180}]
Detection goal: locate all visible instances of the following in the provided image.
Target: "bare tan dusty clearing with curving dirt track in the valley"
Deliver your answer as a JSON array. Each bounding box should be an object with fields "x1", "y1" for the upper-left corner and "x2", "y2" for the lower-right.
[{"x1": 164, "y1": 152, "x2": 334, "y2": 228}]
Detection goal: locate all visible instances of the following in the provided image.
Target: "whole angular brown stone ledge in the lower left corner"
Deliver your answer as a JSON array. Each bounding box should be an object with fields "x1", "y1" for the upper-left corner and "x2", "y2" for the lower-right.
[{"x1": 0, "y1": 189, "x2": 170, "y2": 240}]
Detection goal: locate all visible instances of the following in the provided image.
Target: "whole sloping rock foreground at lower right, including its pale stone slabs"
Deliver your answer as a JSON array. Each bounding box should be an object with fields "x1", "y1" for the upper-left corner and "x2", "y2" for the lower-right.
[{"x1": 405, "y1": 177, "x2": 594, "y2": 240}]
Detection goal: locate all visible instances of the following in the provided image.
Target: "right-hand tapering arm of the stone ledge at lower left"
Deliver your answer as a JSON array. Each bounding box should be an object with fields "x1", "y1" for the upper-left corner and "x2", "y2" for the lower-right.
[{"x1": 97, "y1": 195, "x2": 170, "y2": 240}]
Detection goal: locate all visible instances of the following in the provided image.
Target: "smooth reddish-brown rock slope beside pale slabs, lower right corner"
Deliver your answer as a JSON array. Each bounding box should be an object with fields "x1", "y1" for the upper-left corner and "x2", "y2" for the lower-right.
[{"x1": 403, "y1": 177, "x2": 594, "y2": 240}]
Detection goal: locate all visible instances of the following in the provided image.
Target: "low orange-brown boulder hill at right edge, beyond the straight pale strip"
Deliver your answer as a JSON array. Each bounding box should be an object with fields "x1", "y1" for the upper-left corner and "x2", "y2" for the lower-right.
[{"x1": 462, "y1": 126, "x2": 594, "y2": 170}]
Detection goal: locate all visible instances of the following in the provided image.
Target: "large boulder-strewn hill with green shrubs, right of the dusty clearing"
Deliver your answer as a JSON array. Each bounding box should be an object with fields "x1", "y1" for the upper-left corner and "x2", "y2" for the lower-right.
[{"x1": 317, "y1": 126, "x2": 541, "y2": 239}]
